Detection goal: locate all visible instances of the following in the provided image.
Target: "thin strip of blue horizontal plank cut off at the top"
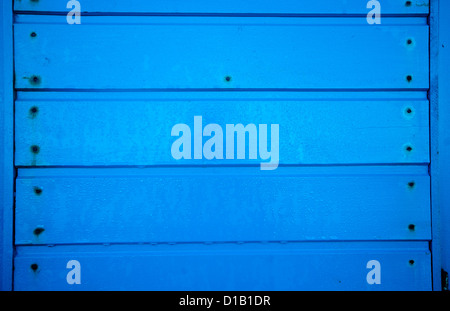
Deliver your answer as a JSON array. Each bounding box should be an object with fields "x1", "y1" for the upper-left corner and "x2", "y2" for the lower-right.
[{"x1": 14, "y1": 0, "x2": 429, "y2": 15}]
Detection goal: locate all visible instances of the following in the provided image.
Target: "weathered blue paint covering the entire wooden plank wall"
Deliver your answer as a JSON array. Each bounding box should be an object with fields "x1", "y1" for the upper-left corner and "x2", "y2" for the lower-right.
[{"x1": 0, "y1": 0, "x2": 450, "y2": 290}]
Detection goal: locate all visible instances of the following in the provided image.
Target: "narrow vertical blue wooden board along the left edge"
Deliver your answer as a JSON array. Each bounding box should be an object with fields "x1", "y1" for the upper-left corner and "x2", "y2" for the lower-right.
[{"x1": 0, "y1": 1, "x2": 14, "y2": 290}]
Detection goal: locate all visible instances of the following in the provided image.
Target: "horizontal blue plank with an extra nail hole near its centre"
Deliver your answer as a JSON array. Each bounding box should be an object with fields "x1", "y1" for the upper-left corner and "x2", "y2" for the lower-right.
[{"x1": 14, "y1": 16, "x2": 429, "y2": 90}]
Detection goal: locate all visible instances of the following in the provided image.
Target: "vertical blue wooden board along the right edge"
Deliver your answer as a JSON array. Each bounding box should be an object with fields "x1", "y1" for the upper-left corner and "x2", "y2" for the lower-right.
[{"x1": 431, "y1": 1, "x2": 450, "y2": 290}]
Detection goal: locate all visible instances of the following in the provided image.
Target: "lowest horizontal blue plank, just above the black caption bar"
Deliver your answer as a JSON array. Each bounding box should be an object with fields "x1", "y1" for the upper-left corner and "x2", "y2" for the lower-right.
[{"x1": 14, "y1": 242, "x2": 431, "y2": 291}]
